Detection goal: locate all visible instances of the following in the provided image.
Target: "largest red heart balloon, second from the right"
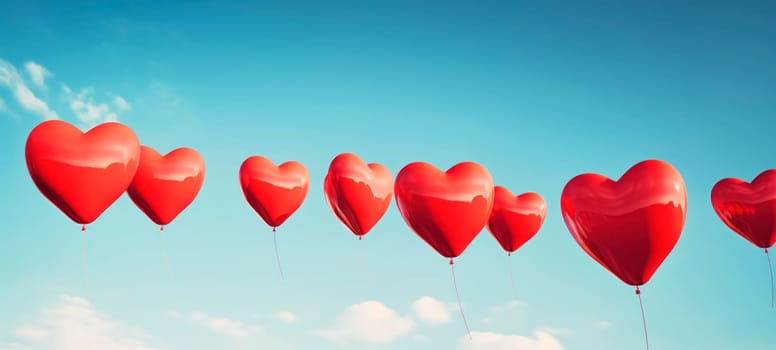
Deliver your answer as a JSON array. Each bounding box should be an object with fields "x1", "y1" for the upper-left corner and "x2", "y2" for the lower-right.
[{"x1": 561, "y1": 160, "x2": 687, "y2": 286}]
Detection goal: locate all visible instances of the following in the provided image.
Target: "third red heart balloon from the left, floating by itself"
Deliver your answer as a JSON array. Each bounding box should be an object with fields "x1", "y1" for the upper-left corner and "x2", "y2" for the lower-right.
[{"x1": 240, "y1": 156, "x2": 310, "y2": 228}]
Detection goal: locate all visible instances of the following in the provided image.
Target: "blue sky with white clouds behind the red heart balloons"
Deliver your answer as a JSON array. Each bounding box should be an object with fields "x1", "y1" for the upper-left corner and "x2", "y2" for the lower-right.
[{"x1": 0, "y1": 1, "x2": 776, "y2": 350}]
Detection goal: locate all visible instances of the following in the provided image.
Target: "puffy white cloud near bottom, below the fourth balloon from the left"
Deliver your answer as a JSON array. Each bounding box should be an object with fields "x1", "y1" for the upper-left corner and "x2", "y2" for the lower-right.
[{"x1": 310, "y1": 301, "x2": 414, "y2": 344}]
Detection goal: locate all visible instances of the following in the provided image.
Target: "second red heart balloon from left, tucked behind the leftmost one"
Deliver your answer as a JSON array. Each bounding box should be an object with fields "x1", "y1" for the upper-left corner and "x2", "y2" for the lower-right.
[{"x1": 127, "y1": 146, "x2": 205, "y2": 225}]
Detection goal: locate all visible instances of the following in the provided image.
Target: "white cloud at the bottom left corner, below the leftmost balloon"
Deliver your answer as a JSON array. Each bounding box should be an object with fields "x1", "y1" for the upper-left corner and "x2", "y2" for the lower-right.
[{"x1": 0, "y1": 296, "x2": 163, "y2": 350}]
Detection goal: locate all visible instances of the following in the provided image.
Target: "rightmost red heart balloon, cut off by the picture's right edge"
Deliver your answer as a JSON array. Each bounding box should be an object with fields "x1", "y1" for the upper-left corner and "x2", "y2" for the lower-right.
[{"x1": 711, "y1": 169, "x2": 776, "y2": 249}]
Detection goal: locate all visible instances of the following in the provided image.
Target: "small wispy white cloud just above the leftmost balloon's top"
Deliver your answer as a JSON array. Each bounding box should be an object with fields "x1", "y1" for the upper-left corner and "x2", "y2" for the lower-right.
[{"x1": 62, "y1": 85, "x2": 130, "y2": 126}]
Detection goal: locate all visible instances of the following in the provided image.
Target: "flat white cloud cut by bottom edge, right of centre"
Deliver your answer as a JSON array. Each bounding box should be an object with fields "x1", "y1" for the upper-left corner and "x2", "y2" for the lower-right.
[{"x1": 458, "y1": 330, "x2": 563, "y2": 350}]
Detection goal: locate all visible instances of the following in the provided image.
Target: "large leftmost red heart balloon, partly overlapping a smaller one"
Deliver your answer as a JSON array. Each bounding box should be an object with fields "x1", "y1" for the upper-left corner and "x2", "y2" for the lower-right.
[{"x1": 25, "y1": 120, "x2": 140, "y2": 225}]
